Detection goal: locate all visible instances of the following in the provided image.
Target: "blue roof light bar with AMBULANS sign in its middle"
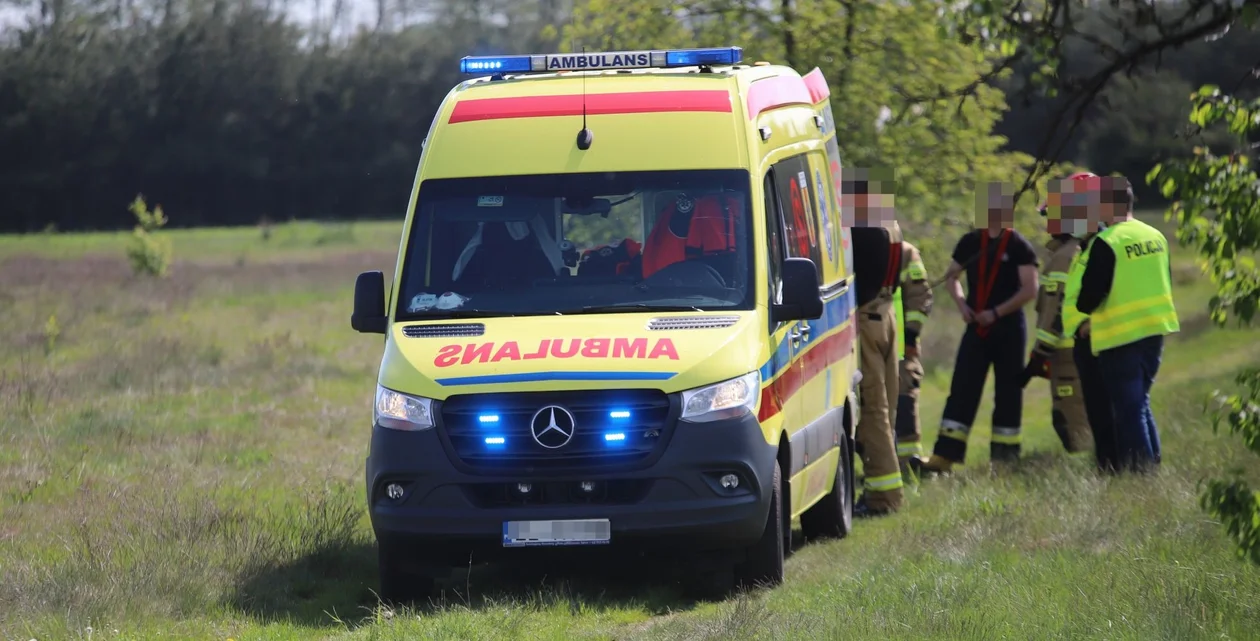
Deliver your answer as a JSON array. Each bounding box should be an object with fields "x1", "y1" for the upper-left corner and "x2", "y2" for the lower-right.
[{"x1": 460, "y1": 47, "x2": 743, "y2": 73}]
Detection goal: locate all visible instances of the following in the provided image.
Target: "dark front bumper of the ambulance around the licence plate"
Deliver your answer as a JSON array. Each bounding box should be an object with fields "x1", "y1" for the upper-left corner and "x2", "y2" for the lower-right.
[{"x1": 367, "y1": 414, "x2": 776, "y2": 563}]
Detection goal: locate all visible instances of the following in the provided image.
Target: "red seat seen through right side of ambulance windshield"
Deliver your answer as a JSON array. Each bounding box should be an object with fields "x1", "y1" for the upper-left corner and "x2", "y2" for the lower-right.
[{"x1": 643, "y1": 194, "x2": 738, "y2": 278}]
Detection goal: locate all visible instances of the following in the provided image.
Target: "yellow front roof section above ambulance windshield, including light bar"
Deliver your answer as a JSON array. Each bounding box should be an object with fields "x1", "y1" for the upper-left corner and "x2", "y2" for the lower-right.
[{"x1": 421, "y1": 48, "x2": 825, "y2": 179}]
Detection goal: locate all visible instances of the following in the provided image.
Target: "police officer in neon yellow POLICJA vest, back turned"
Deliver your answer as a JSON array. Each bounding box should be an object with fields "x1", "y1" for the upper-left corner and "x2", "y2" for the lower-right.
[{"x1": 1076, "y1": 178, "x2": 1181, "y2": 471}]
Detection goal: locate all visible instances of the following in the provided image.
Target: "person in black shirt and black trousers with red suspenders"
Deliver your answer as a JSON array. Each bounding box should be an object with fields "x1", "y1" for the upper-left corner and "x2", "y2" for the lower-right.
[{"x1": 921, "y1": 188, "x2": 1040, "y2": 472}]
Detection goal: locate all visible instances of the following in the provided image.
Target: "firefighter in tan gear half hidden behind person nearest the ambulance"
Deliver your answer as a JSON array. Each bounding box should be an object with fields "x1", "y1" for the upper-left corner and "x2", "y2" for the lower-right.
[{"x1": 893, "y1": 241, "x2": 932, "y2": 474}]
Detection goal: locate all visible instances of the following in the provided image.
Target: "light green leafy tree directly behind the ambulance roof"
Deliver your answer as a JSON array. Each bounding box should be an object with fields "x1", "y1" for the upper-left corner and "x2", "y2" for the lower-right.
[{"x1": 559, "y1": 0, "x2": 1038, "y2": 259}]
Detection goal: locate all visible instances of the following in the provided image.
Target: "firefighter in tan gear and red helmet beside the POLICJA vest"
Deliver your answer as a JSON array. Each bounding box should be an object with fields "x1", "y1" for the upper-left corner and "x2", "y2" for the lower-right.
[{"x1": 1023, "y1": 173, "x2": 1100, "y2": 453}]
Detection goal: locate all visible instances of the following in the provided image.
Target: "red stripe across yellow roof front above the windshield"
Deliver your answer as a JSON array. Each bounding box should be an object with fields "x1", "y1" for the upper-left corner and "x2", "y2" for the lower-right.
[{"x1": 449, "y1": 89, "x2": 731, "y2": 125}]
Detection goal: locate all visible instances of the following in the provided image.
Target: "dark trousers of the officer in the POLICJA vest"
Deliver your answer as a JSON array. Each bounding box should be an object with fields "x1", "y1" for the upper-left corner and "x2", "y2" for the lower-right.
[{"x1": 1099, "y1": 336, "x2": 1164, "y2": 470}]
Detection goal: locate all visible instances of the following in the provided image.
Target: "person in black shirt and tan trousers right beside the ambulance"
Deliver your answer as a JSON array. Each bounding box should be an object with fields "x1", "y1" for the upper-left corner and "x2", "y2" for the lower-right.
[{"x1": 843, "y1": 169, "x2": 903, "y2": 518}]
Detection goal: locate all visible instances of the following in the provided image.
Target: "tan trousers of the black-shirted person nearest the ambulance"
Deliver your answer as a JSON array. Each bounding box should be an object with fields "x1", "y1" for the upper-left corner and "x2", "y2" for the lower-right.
[{"x1": 857, "y1": 298, "x2": 902, "y2": 510}]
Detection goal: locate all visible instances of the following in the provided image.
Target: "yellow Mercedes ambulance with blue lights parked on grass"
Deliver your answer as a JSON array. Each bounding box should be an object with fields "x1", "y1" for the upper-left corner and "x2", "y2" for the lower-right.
[{"x1": 352, "y1": 47, "x2": 858, "y2": 599}]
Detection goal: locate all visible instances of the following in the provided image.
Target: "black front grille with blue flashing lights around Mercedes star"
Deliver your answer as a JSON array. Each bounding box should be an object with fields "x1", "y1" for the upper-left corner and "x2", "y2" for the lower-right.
[{"x1": 441, "y1": 389, "x2": 672, "y2": 474}]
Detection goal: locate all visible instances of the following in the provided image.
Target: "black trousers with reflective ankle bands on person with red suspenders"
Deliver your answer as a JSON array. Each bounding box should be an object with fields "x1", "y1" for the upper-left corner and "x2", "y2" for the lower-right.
[{"x1": 932, "y1": 311, "x2": 1028, "y2": 462}]
